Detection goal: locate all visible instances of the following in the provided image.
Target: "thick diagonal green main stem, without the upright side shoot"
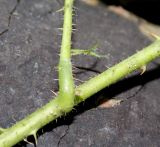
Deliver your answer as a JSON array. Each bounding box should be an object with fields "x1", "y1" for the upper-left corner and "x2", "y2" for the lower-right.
[{"x1": 0, "y1": 40, "x2": 160, "y2": 147}]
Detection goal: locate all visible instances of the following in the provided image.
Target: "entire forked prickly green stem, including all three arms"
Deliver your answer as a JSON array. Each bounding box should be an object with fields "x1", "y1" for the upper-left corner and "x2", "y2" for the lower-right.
[{"x1": 0, "y1": 0, "x2": 160, "y2": 147}]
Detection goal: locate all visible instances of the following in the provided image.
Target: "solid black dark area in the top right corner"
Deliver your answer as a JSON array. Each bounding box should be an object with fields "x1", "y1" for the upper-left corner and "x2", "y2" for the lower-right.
[{"x1": 101, "y1": 0, "x2": 160, "y2": 24}]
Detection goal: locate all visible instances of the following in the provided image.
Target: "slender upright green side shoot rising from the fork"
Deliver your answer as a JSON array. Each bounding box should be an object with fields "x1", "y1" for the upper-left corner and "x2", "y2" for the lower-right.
[{"x1": 58, "y1": 0, "x2": 75, "y2": 112}]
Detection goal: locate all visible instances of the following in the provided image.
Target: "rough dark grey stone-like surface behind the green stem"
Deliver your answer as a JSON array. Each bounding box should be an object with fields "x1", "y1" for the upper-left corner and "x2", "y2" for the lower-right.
[{"x1": 0, "y1": 0, "x2": 160, "y2": 147}]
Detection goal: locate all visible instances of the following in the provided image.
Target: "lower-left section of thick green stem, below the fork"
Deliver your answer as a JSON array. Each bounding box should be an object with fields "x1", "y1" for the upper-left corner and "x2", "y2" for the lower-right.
[{"x1": 0, "y1": 97, "x2": 64, "y2": 147}]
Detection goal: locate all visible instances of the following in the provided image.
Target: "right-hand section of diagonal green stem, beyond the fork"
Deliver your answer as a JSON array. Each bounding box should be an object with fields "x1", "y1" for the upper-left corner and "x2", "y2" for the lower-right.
[{"x1": 76, "y1": 39, "x2": 160, "y2": 102}]
